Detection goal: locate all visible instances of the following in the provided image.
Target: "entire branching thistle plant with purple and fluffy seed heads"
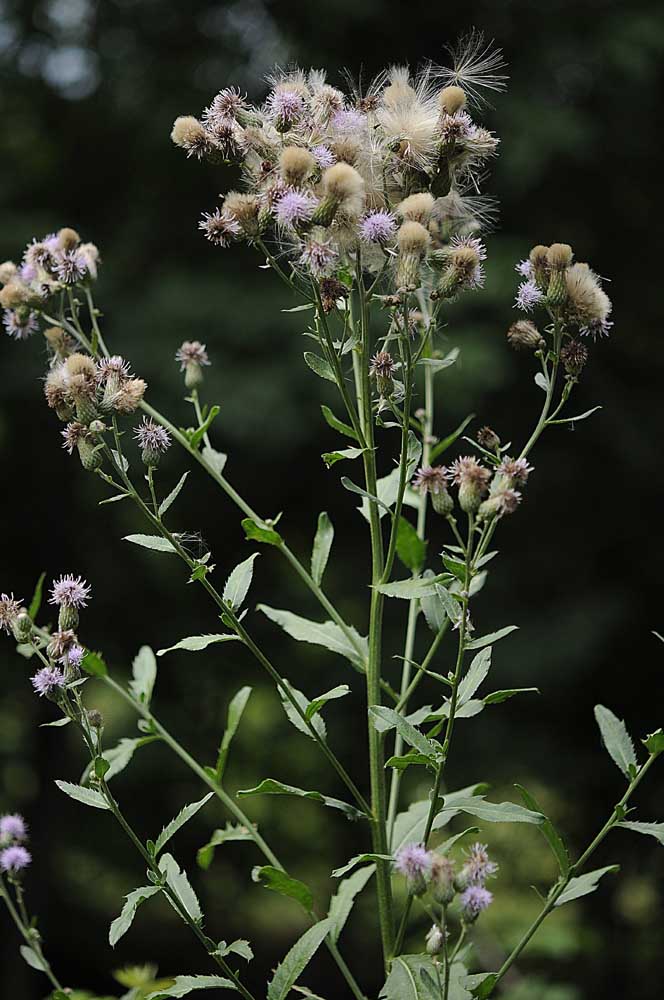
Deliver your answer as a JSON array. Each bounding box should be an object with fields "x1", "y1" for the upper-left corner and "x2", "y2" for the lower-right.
[{"x1": 0, "y1": 35, "x2": 664, "y2": 1000}]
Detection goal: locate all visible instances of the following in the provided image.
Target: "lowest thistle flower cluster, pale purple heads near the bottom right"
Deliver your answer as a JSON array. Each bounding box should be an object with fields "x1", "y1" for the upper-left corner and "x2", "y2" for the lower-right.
[{"x1": 394, "y1": 843, "x2": 498, "y2": 940}]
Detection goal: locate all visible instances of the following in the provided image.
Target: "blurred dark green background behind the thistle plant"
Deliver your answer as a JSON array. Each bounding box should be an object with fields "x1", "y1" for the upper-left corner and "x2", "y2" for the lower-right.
[{"x1": 0, "y1": 0, "x2": 664, "y2": 1000}]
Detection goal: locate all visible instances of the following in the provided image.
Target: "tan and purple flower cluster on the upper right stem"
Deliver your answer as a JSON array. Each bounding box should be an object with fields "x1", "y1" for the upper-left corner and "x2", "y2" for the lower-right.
[{"x1": 508, "y1": 243, "x2": 613, "y2": 340}]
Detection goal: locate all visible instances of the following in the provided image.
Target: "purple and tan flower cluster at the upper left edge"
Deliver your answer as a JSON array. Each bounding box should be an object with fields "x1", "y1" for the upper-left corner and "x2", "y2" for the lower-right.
[{"x1": 0, "y1": 228, "x2": 99, "y2": 340}]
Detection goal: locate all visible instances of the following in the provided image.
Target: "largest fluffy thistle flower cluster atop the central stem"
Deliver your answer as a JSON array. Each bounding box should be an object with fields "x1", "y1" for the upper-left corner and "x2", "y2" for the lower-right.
[{"x1": 171, "y1": 45, "x2": 504, "y2": 298}]
